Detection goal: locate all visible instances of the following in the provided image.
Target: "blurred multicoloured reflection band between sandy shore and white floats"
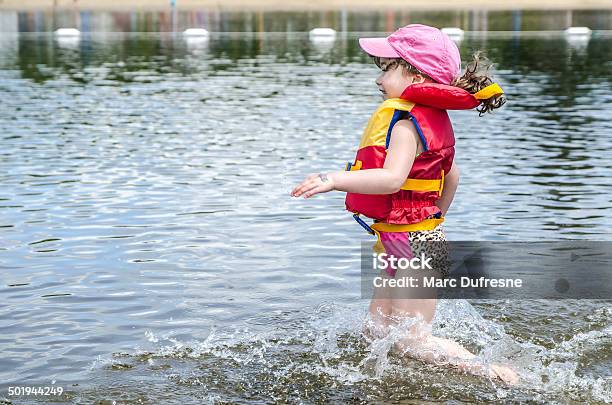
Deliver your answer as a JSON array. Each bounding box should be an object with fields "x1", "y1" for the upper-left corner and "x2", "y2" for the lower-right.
[{"x1": 0, "y1": 8, "x2": 612, "y2": 33}]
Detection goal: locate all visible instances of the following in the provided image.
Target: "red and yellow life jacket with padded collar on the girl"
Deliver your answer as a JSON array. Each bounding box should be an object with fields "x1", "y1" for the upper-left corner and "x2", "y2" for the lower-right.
[{"x1": 346, "y1": 83, "x2": 480, "y2": 229}]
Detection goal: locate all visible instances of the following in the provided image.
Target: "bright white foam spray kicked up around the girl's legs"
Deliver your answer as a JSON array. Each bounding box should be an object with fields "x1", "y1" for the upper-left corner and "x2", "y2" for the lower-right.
[{"x1": 131, "y1": 300, "x2": 612, "y2": 402}]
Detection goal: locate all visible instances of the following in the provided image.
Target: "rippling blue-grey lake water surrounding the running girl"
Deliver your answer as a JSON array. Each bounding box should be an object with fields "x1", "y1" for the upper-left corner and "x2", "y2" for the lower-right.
[{"x1": 0, "y1": 18, "x2": 612, "y2": 404}]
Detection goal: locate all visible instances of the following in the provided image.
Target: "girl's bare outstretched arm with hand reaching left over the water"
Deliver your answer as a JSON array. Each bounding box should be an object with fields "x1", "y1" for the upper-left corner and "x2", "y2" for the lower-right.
[{"x1": 291, "y1": 120, "x2": 420, "y2": 198}]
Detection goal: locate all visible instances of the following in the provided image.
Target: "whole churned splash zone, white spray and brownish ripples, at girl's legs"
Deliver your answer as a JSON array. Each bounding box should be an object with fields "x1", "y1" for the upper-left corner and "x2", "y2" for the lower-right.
[{"x1": 110, "y1": 300, "x2": 612, "y2": 402}]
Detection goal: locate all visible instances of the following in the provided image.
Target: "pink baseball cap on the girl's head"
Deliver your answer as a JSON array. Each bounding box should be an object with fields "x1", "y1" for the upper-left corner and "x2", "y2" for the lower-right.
[{"x1": 359, "y1": 24, "x2": 461, "y2": 84}]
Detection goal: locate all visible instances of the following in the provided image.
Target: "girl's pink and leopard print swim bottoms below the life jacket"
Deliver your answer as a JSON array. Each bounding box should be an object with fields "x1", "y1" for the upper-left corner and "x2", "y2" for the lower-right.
[{"x1": 380, "y1": 225, "x2": 450, "y2": 278}]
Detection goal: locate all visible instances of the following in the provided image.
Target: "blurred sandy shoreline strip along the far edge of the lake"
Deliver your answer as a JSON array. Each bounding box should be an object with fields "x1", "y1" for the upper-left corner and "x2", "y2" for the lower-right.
[{"x1": 0, "y1": 0, "x2": 612, "y2": 11}]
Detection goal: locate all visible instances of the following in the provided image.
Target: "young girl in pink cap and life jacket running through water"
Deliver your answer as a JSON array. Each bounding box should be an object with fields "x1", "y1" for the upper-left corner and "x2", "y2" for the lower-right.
[{"x1": 291, "y1": 24, "x2": 518, "y2": 383}]
